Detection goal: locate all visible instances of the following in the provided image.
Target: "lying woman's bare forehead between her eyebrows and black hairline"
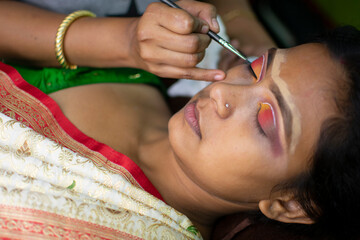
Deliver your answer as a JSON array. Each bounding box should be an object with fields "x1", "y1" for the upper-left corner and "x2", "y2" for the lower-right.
[{"x1": 279, "y1": 44, "x2": 341, "y2": 165}]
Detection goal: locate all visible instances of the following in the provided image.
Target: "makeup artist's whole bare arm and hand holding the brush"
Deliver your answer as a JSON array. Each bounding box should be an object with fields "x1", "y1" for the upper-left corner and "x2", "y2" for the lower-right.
[{"x1": 0, "y1": 0, "x2": 224, "y2": 80}]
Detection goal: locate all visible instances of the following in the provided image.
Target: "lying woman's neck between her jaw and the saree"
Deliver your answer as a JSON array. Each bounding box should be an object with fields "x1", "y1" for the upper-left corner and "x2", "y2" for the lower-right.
[{"x1": 136, "y1": 132, "x2": 257, "y2": 239}]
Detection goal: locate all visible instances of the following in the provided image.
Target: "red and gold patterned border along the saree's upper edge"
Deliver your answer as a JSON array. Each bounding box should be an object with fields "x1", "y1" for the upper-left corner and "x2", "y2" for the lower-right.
[{"x1": 0, "y1": 62, "x2": 163, "y2": 200}]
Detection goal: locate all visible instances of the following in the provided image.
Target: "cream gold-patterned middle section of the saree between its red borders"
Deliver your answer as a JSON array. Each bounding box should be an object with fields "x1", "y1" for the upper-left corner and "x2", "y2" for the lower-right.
[{"x1": 0, "y1": 100, "x2": 199, "y2": 239}]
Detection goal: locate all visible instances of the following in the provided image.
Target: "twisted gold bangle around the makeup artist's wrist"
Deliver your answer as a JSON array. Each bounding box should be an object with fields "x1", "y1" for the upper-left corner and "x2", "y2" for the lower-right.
[{"x1": 55, "y1": 10, "x2": 96, "y2": 69}]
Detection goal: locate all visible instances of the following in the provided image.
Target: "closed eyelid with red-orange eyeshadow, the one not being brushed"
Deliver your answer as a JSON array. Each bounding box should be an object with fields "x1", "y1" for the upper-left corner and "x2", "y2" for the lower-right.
[{"x1": 256, "y1": 103, "x2": 276, "y2": 138}]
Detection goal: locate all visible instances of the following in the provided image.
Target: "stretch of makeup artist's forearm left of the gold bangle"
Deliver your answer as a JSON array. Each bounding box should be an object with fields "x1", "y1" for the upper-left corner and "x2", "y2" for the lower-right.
[{"x1": 0, "y1": 1, "x2": 64, "y2": 66}]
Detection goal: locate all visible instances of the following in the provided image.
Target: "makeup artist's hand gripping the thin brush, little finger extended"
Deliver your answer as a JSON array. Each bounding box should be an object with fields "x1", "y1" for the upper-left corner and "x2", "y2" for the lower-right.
[{"x1": 132, "y1": 0, "x2": 225, "y2": 81}]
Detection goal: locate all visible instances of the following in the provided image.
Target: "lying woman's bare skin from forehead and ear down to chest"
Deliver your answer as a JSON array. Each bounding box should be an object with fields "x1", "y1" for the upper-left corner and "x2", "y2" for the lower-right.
[{"x1": 50, "y1": 44, "x2": 341, "y2": 239}]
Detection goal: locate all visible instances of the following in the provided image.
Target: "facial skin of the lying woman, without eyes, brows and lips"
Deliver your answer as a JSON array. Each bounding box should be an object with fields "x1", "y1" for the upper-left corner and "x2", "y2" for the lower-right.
[{"x1": 169, "y1": 45, "x2": 333, "y2": 206}]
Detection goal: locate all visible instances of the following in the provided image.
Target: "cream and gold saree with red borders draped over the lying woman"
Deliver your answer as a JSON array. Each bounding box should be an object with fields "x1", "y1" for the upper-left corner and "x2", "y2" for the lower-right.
[{"x1": 0, "y1": 62, "x2": 201, "y2": 239}]
